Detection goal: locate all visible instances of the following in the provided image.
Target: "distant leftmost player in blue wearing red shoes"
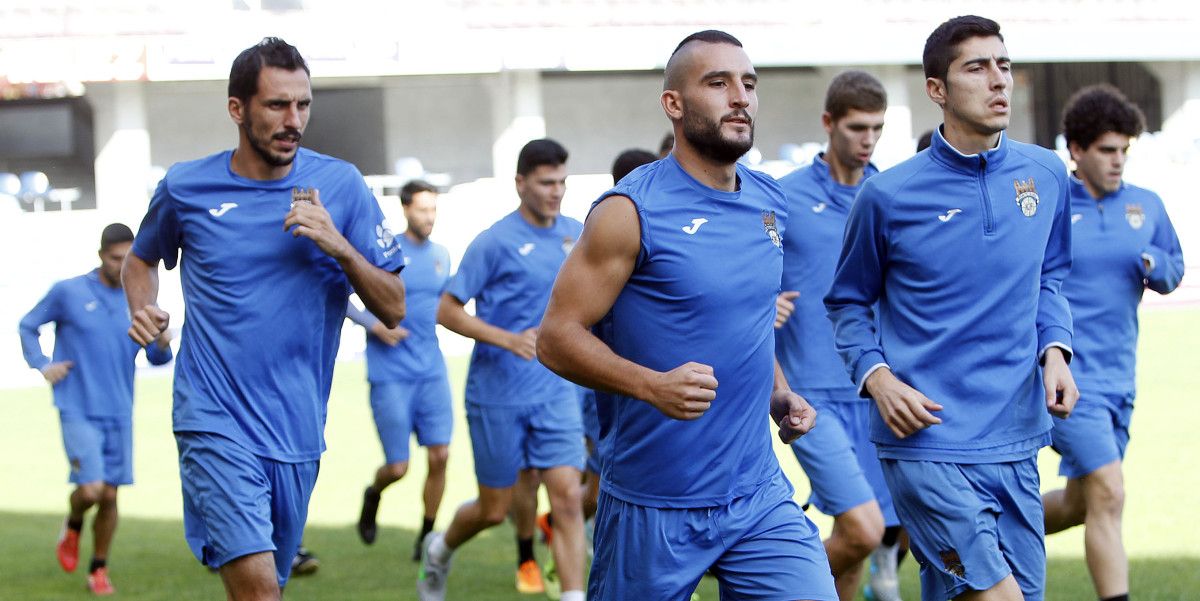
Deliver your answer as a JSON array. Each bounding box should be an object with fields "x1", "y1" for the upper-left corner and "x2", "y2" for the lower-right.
[{"x1": 20, "y1": 223, "x2": 172, "y2": 595}]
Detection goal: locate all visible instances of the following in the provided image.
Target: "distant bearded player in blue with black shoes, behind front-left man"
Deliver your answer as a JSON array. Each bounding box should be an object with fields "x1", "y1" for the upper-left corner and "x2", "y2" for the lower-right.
[{"x1": 347, "y1": 180, "x2": 454, "y2": 561}]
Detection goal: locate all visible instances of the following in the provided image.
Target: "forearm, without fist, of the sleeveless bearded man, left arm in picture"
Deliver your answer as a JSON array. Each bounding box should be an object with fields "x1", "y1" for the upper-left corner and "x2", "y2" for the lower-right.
[{"x1": 538, "y1": 320, "x2": 662, "y2": 402}]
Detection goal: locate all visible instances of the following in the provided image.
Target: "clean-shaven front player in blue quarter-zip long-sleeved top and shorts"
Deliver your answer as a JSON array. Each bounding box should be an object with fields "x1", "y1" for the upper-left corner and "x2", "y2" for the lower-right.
[{"x1": 826, "y1": 16, "x2": 1079, "y2": 601}]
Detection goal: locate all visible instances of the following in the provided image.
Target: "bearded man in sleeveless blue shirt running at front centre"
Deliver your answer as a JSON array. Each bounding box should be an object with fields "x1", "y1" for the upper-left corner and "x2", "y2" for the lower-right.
[{"x1": 538, "y1": 31, "x2": 836, "y2": 601}]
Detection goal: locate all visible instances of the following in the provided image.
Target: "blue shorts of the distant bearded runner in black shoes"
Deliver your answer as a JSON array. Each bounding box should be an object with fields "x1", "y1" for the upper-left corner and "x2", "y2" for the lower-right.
[{"x1": 371, "y1": 378, "x2": 454, "y2": 463}]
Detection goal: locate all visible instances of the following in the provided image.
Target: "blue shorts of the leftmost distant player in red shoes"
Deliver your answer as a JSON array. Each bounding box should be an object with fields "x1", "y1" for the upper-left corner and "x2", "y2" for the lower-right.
[{"x1": 59, "y1": 411, "x2": 133, "y2": 486}]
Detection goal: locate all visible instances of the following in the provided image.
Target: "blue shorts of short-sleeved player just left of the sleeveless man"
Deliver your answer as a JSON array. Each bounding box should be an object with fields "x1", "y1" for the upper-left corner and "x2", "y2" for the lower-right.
[{"x1": 467, "y1": 398, "x2": 583, "y2": 488}]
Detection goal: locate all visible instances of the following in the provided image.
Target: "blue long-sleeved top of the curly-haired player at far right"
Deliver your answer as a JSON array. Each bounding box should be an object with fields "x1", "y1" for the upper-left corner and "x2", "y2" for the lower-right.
[{"x1": 1062, "y1": 178, "x2": 1183, "y2": 395}]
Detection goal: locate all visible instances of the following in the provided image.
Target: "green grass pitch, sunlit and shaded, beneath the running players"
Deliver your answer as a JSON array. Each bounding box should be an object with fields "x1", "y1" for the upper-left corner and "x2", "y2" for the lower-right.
[{"x1": 0, "y1": 308, "x2": 1200, "y2": 601}]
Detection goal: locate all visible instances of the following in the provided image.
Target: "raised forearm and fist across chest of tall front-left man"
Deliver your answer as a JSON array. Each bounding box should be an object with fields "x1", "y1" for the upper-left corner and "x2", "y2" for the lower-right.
[{"x1": 283, "y1": 190, "x2": 404, "y2": 327}]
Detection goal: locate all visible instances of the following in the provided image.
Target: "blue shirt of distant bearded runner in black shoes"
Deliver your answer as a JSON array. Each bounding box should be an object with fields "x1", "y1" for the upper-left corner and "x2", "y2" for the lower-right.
[{"x1": 347, "y1": 234, "x2": 450, "y2": 384}]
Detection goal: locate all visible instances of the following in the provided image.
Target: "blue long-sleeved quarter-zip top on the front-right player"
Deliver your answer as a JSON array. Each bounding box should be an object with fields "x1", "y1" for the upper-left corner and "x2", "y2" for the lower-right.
[{"x1": 826, "y1": 132, "x2": 1072, "y2": 463}]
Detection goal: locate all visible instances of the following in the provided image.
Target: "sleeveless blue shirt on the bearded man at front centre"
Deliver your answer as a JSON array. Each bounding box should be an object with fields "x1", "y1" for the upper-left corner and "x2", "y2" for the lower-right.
[{"x1": 594, "y1": 155, "x2": 787, "y2": 507}]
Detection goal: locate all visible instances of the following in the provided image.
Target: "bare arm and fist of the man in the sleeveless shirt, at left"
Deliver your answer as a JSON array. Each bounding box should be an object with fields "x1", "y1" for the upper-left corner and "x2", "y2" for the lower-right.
[{"x1": 538, "y1": 196, "x2": 716, "y2": 420}]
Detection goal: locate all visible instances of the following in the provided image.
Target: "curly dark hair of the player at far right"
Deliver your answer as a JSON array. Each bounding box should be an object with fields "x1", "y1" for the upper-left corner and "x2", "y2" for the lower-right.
[{"x1": 1062, "y1": 84, "x2": 1146, "y2": 149}]
